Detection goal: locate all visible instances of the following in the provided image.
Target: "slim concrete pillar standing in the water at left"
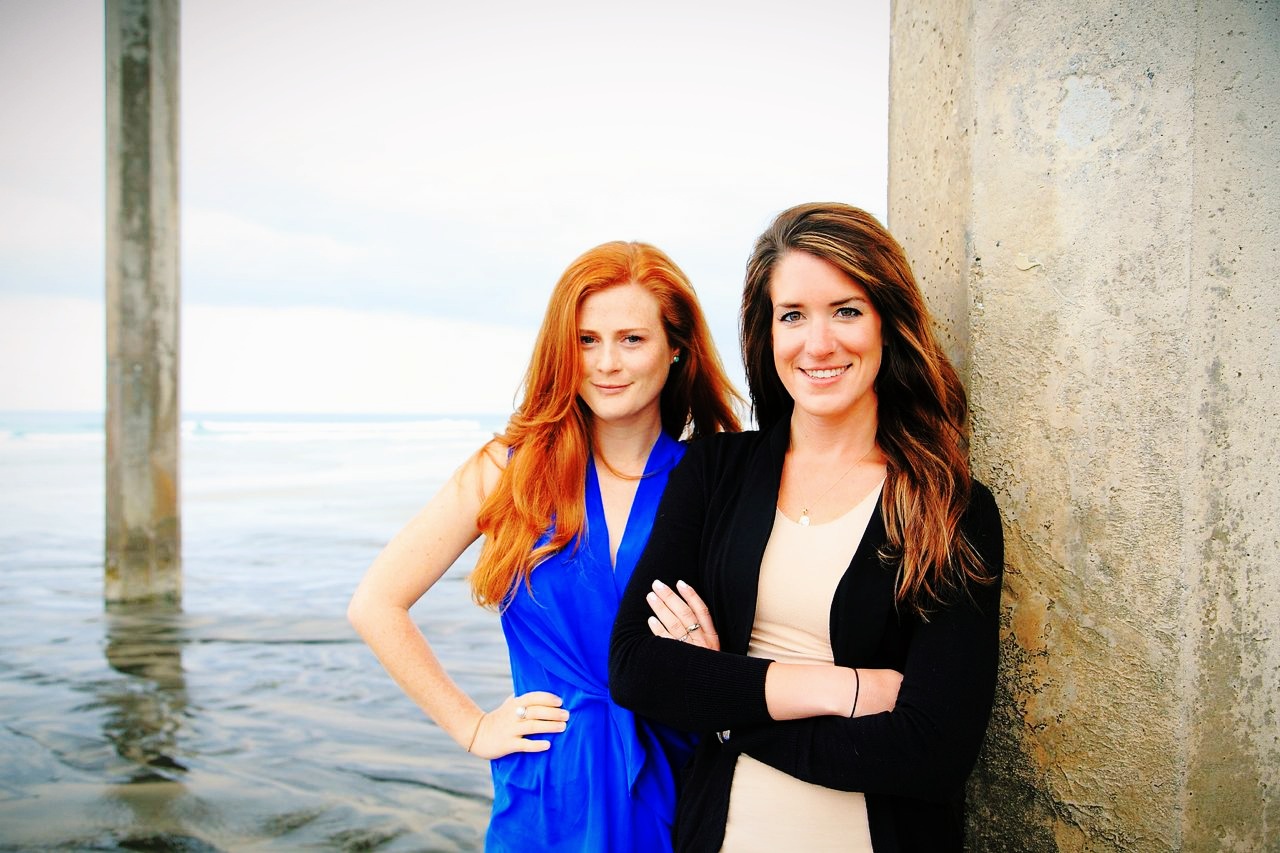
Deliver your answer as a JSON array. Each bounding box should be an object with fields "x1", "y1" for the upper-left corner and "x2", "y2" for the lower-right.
[{"x1": 105, "y1": 0, "x2": 182, "y2": 602}]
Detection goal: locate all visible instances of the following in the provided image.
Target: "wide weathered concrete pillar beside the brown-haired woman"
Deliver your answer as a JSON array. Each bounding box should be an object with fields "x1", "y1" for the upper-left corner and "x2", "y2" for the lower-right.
[{"x1": 888, "y1": 0, "x2": 1280, "y2": 850}]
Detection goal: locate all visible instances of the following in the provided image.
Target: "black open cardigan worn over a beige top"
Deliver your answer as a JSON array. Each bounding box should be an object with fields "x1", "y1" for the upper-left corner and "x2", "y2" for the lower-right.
[{"x1": 609, "y1": 419, "x2": 1004, "y2": 853}]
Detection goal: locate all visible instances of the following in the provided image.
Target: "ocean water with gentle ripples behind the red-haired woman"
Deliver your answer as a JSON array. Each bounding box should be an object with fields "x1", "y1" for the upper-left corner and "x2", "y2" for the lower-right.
[{"x1": 0, "y1": 414, "x2": 511, "y2": 850}]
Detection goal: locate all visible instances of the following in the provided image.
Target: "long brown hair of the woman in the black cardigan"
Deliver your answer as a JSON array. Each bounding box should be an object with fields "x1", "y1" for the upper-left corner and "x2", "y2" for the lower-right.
[{"x1": 741, "y1": 202, "x2": 989, "y2": 615}]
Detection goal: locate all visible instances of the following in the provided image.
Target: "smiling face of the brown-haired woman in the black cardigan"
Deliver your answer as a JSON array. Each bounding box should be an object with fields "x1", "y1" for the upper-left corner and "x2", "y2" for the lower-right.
[{"x1": 769, "y1": 251, "x2": 883, "y2": 420}]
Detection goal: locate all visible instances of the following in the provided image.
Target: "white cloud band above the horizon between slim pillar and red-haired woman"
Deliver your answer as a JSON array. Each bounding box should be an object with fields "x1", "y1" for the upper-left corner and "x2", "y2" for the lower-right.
[{"x1": 182, "y1": 306, "x2": 535, "y2": 414}]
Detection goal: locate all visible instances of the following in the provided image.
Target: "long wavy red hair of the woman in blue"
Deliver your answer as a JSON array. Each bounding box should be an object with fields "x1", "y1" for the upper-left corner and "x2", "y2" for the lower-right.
[{"x1": 471, "y1": 242, "x2": 739, "y2": 608}]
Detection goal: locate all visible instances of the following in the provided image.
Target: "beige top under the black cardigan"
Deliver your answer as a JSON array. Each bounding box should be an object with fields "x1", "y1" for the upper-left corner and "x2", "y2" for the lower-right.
[{"x1": 721, "y1": 483, "x2": 883, "y2": 853}]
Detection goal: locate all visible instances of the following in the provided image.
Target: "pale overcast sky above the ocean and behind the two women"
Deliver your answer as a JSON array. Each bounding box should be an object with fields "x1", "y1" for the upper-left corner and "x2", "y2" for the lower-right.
[{"x1": 0, "y1": 0, "x2": 888, "y2": 412}]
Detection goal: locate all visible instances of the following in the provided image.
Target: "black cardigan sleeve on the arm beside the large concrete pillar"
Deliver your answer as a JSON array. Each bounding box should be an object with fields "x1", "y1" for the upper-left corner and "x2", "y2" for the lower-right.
[{"x1": 732, "y1": 483, "x2": 1004, "y2": 802}]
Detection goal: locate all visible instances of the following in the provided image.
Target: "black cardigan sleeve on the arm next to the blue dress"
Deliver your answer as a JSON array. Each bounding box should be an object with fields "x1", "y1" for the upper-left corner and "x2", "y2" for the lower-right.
[{"x1": 609, "y1": 435, "x2": 771, "y2": 731}]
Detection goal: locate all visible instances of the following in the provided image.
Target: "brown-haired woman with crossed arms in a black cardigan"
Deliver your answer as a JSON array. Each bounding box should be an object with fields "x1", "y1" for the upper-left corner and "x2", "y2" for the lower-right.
[{"x1": 609, "y1": 204, "x2": 1004, "y2": 853}]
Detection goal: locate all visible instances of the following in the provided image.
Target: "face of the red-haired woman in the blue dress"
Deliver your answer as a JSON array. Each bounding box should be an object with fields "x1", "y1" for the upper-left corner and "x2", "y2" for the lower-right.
[{"x1": 577, "y1": 282, "x2": 677, "y2": 425}]
